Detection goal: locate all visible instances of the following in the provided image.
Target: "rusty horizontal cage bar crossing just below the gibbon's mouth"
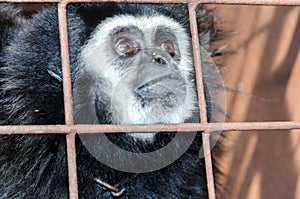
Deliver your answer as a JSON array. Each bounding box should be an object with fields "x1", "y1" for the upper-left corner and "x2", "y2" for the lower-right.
[{"x1": 0, "y1": 122, "x2": 300, "y2": 134}]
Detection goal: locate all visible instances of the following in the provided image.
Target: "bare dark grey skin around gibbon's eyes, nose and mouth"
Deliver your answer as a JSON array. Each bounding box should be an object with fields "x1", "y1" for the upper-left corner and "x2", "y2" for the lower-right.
[{"x1": 111, "y1": 26, "x2": 186, "y2": 108}]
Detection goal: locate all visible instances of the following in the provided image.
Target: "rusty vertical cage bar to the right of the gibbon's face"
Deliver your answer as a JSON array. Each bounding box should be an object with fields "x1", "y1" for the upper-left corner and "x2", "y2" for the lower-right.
[{"x1": 188, "y1": 3, "x2": 216, "y2": 199}]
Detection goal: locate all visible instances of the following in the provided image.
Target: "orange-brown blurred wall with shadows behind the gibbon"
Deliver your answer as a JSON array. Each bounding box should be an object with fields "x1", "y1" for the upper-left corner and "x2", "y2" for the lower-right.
[{"x1": 215, "y1": 6, "x2": 300, "y2": 199}]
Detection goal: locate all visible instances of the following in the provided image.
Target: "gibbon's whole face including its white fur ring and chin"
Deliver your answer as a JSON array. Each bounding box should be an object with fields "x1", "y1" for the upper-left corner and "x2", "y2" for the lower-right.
[{"x1": 74, "y1": 15, "x2": 196, "y2": 140}]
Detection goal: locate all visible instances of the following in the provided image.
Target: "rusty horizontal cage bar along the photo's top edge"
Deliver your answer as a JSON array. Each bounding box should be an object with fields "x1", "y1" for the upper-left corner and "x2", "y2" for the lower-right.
[{"x1": 0, "y1": 0, "x2": 300, "y2": 6}]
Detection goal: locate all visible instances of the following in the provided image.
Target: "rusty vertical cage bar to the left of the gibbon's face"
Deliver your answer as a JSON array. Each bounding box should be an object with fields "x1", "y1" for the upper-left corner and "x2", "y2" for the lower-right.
[{"x1": 58, "y1": 1, "x2": 78, "y2": 199}]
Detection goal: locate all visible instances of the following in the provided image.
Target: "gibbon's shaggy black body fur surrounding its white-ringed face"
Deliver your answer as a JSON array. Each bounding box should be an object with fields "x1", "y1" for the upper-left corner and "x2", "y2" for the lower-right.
[{"x1": 0, "y1": 3, "x2": 221, "y2": 199}]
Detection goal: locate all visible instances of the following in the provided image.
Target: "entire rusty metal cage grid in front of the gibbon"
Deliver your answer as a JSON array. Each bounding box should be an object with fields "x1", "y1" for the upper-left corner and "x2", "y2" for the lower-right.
[{"x1": 0, "y1": 0, "x2": 300, "y2": 199}]
